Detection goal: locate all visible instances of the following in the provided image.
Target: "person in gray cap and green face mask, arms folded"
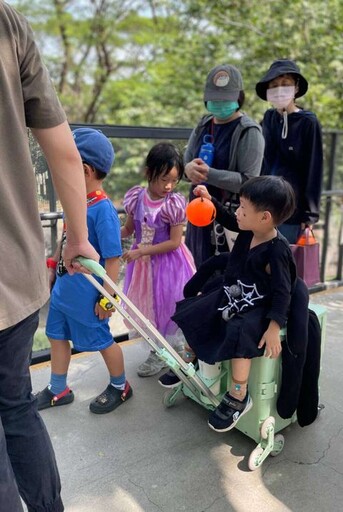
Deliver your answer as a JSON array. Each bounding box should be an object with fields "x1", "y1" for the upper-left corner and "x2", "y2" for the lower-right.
[{"x1": 184, "y1": 64, "x2": 264, "y2": 267}]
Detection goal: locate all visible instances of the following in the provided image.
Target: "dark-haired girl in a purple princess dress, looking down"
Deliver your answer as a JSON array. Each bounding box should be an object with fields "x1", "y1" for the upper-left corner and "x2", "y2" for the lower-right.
[{"x1": 121, "y1": 143, "x2": 195, "y2": 377}]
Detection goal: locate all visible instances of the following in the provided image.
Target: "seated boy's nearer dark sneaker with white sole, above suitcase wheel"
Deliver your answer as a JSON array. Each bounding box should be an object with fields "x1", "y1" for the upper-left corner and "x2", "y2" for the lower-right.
[{"x1": 208, "y1": 393, "x2": 253, "y2": 432}]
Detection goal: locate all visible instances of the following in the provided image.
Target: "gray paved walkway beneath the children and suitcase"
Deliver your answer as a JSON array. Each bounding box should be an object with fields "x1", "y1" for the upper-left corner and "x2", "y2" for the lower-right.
[{"x1": 30, "y1": 288, "x2": 343, "y2": 512}]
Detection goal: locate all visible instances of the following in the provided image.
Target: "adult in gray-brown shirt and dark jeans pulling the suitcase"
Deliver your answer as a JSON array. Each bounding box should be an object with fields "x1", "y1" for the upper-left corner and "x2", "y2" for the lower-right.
[{"x1": 0, "y1": 0, "x2": 98, "y2": 512}]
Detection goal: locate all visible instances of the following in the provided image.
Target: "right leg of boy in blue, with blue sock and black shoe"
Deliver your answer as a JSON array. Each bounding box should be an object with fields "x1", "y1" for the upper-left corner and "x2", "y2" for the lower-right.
[{"x1": 89, "y1": 343, "x2": 132, "y2": 414}]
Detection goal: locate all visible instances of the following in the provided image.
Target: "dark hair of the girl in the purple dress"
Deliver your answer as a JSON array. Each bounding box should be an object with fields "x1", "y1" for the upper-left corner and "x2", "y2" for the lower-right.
[{"x1": 145, "y1": 142, "x2": 184, "y2": 181}]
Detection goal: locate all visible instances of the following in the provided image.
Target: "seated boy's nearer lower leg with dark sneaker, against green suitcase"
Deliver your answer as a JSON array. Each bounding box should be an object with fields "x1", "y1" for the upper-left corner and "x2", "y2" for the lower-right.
[{"x1": 208, "y1": 358, "x2": 252, "y2": 432}]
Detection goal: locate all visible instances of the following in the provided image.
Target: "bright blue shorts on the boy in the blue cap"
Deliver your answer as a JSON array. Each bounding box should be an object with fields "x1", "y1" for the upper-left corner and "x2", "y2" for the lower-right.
[{"x1": 45, "y1": 304, "x2": 114, "y2": 352}]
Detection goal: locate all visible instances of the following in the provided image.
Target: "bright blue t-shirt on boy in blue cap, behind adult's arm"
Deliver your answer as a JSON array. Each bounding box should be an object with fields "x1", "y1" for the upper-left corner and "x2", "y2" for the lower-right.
[{"x1": 50, "y1": 199, "x2": 122, "y2": 327}]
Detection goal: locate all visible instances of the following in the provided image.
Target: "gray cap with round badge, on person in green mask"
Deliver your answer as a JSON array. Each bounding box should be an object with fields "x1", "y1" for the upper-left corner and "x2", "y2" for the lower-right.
[{"x1": 204, "y1": 64, "x2": 243, "y2": 102}]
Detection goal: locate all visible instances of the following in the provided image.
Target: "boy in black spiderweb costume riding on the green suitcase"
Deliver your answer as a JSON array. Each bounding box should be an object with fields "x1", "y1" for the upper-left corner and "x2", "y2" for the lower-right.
[{"x1": 159, "y1": 176, "x2": 296, "y2": 432}]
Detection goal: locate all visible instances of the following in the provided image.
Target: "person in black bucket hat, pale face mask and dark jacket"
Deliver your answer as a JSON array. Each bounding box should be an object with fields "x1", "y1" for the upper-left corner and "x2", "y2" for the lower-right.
[{"x1": 256, "y1": 59, "x2": 323, "y2": 243}]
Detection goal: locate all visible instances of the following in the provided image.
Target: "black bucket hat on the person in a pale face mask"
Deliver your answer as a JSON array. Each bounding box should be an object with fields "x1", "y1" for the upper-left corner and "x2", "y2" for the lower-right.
[{"x1": 255, "y1": 59, "x2": 308, "y2": 100}]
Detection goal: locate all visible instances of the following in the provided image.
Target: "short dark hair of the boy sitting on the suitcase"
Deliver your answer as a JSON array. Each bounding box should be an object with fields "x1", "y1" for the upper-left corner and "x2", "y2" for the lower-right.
[{"x1": 239, "y1": 176, "x2": 295, "y2": 226}]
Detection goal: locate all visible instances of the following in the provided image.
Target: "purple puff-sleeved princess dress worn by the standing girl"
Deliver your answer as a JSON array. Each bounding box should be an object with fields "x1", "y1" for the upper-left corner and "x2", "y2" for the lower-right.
[{"x1": 123, "y1": 186, "x2": 195, "y2": 347}]
